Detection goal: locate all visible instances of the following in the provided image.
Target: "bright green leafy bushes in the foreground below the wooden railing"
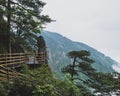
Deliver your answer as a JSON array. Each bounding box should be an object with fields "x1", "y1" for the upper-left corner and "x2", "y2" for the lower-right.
[{"x1": 0, "y1": 65, "x2": 81, "y2": 96}]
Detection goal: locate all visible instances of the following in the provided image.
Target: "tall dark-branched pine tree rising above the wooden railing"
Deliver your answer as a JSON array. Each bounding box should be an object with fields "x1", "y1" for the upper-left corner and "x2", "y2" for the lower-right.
[{"x1": 0, "y1": 0, "x2": 51, "y2": 52}]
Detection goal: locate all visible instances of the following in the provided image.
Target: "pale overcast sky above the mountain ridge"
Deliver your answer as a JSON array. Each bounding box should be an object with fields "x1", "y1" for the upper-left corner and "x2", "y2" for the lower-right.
[{"x1": 43, "y1": 0, "x2": 120, "y2": 62}]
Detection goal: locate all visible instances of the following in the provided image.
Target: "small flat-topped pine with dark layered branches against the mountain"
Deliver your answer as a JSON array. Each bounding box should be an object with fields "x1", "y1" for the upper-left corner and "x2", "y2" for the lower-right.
[{"x1": 62, "y1": 50, "x2": 95, "y2": 79}]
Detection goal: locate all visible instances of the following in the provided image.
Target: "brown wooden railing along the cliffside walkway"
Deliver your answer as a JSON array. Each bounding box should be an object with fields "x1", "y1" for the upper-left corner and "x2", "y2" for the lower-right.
[{"x1": 0, "y1": 52, "x2": 47, "y2": 80}]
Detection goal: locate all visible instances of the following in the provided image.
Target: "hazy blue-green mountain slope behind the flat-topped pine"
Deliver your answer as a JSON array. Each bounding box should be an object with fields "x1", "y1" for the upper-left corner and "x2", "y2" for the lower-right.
[{"x1": 42, "y1": 31, "x2": 117, "y2": 74}]
